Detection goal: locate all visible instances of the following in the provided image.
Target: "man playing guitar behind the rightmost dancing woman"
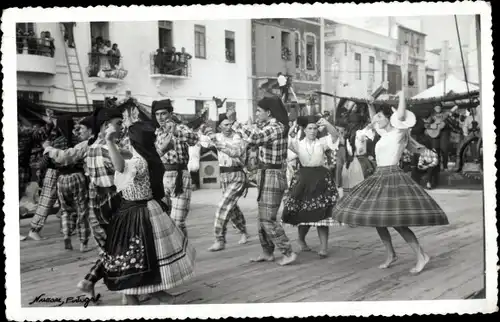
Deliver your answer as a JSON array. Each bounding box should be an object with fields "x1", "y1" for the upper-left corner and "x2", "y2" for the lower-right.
[{"x1": 424, "y1": 105, "x2": 458, "y2": 170}]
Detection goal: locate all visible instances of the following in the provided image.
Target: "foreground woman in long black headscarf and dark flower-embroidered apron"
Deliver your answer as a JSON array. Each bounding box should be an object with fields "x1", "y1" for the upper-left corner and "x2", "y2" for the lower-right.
[{"x1": 103, "y1": 121, "x2": 195, "y2": 305}]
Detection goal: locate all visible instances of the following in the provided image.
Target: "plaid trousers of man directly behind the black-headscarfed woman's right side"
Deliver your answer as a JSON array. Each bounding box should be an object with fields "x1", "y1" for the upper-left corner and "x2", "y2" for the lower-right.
[{"x1": 163, "y1": 170, "x2": 193, "y2": 235}]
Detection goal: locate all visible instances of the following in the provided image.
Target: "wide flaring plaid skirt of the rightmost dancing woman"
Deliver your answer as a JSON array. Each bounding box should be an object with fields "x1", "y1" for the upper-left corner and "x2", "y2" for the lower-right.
[{"x1": 333, "y1": 165, "x2": 448, "y2": 227}]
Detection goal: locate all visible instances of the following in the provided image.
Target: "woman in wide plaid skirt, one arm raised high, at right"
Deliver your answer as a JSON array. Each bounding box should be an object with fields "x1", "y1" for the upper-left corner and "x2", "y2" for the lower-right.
[{"x1": 334, "y1": 89, "x2": 448, "y2": 274}]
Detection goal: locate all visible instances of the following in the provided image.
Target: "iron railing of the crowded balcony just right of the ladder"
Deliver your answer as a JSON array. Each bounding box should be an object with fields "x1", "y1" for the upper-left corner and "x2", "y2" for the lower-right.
[{"x1": 87, "y1": 53, "x2": 128, "y2": 80}]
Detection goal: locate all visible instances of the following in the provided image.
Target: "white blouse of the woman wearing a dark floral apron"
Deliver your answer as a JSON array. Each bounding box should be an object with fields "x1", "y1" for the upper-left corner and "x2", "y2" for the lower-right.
[{"x1": 288, "y1": 135, "x2": 338, "y2": 167}]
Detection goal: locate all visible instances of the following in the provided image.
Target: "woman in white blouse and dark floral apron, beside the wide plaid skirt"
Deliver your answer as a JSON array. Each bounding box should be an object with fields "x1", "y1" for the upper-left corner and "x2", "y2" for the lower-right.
[{"x1": 282, "y1": 116, "x2": 339, "y2": 258}]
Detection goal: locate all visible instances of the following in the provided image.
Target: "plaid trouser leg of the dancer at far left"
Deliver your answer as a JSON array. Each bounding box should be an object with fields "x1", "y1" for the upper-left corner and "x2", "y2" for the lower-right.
[{"x1": 31, "y1": 168, "x2": 59, "y2": 232}]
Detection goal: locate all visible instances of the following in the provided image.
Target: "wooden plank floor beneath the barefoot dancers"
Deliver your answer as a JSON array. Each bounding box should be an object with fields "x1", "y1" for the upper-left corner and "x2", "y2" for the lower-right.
[{"x1": 20, "y1": 189, "x2": 484, "y2": 306}]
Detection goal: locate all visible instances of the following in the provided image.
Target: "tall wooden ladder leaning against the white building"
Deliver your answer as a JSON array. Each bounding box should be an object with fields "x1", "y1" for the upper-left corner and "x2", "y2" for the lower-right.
[{"x1": 59, "y1": 23, "x2": 90, "y2": 111}]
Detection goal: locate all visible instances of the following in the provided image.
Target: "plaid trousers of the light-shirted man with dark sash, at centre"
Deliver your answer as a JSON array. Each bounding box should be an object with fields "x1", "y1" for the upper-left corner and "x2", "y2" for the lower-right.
[{"x1": 214, "y1": 171, "x2": 247, "y2": 243}]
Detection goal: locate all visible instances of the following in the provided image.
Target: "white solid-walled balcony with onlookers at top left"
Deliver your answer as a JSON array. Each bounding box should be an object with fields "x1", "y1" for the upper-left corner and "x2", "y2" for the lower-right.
[{"x1": 16, "y1": 36, "x2": 56, "y2": 75}]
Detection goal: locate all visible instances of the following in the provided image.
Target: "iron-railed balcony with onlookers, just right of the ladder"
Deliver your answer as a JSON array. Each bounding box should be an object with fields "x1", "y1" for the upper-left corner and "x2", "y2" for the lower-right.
[{"x1": 87, "y1": 52, "x2": 128, "y2": 87}]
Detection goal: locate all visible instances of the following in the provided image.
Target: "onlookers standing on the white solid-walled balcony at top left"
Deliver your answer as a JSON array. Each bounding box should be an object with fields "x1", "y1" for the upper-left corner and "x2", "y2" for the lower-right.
[{"x1": 16, "y1": 29, "x2": 56, "y2": 57}]
